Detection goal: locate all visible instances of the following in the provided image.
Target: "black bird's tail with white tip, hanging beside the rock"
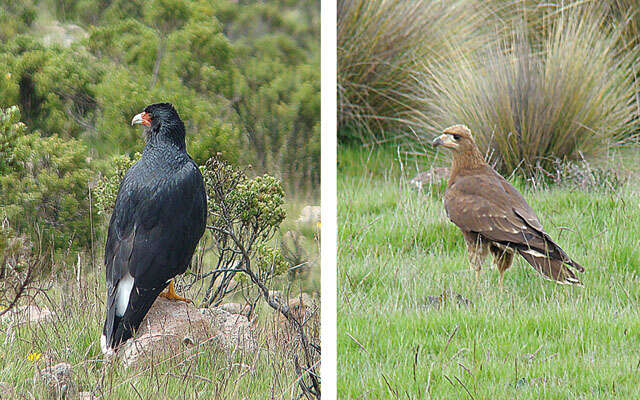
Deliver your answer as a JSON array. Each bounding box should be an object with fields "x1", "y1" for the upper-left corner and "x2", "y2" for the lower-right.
[{"x1": 101, "y1": 285, "x2": 166, "y2": 353}]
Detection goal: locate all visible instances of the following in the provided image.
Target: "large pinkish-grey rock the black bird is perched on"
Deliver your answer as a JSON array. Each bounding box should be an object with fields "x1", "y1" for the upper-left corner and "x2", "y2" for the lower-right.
[{"x1": 119, "y1": 297, "x2": 256, "y2": 367}]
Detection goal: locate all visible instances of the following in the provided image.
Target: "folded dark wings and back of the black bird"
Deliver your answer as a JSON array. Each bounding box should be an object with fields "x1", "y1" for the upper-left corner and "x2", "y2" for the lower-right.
[{"x1": 105, "y1": 161, "x2": 206, "y2": 288}]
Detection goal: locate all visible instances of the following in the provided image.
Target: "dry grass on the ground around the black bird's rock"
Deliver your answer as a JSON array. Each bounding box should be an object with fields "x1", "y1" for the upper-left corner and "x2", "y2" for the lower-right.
[{"x1": 0, "y1": 271, "x2": 319, "y2": 399}]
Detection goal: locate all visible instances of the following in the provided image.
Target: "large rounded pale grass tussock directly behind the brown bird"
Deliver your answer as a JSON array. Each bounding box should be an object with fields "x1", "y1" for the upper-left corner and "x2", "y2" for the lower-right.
[{"x1": 422, "y1": 9, "x2": 637, "y2": 174}]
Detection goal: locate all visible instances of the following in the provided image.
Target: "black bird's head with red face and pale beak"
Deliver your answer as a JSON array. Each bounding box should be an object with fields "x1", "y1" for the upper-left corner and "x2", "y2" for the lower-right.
[{"x1": 131, "y1": 103, "x2": 185, "y2": 148}]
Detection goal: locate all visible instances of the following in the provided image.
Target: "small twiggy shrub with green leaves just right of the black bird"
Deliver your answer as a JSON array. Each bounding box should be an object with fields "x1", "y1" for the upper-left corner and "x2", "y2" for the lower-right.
[{"x1": 201, "y1": 158, "x2": 287, "y2": 305}]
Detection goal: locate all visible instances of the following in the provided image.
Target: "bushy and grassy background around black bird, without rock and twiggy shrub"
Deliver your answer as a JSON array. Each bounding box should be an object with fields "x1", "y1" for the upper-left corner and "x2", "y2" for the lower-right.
[{"x1": 0, "y1": 0, "x2": 320, "y2": 398}]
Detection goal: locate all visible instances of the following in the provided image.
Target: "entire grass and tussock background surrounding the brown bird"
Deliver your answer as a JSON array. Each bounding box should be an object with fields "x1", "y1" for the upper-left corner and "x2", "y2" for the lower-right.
[{"x1": 338, "y1": 0, "x2": 640, "y2": 399}]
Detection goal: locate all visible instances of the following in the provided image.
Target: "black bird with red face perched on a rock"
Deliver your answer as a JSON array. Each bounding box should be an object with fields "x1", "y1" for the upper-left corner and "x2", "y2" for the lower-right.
[{"x1": 100, "y1": 103, "x2": 207, "y2": 353}]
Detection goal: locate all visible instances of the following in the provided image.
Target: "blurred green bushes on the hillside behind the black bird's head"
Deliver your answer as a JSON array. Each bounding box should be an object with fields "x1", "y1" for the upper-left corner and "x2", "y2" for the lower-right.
[{"x1": 0, "y1": 0, "x2": 320, "y2": 197}]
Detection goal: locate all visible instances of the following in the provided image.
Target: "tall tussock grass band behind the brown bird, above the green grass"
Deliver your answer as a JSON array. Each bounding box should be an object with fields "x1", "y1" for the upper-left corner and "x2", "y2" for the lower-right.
[{"x1": 338, "y1": 0, "x2": 640, "y2": 175}]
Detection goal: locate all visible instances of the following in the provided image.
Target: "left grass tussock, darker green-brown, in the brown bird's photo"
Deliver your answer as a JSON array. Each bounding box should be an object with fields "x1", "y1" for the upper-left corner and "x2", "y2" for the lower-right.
[{"x1": 338, "y1": 0, "x2": 482, "y2": 142}]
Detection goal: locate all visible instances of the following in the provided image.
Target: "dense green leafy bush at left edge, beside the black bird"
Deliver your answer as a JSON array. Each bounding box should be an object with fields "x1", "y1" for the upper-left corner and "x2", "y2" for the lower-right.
[{"x1": 0, "y1": 106, "x2": 92, "y2": 256}]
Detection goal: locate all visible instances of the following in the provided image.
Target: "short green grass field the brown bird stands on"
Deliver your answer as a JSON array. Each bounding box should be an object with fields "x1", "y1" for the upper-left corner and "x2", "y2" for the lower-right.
[{"x1": 338, "y1": 147, "x2": 640, "y2": 399}]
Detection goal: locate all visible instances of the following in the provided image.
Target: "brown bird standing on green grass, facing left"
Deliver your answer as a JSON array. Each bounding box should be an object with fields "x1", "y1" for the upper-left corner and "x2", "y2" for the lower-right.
[{"x1": 433, "y1": 125, "x2": 584, "y2": 287}]
